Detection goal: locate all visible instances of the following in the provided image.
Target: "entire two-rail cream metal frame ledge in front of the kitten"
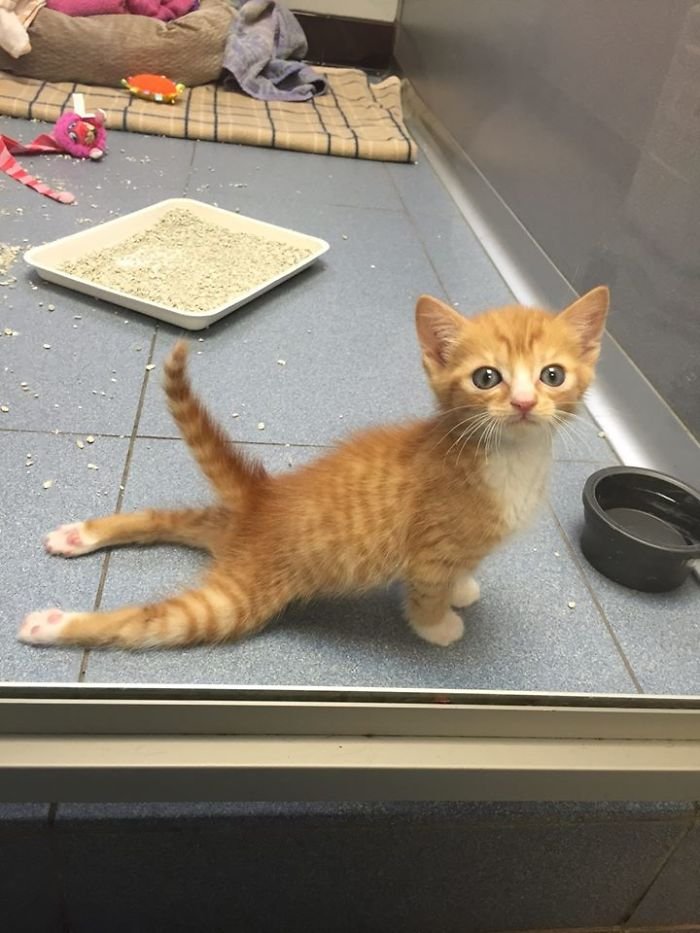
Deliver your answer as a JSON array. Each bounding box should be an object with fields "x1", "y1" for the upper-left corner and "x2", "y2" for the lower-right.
[{"x1": 0, "y1": 686, "x2": 700, "y2": 802}]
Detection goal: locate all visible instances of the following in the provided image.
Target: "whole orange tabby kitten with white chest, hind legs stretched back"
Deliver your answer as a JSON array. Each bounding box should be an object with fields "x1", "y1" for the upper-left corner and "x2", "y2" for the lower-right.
[{"x1": 19, "y1": 287, "x2": 609, "y2": 648}]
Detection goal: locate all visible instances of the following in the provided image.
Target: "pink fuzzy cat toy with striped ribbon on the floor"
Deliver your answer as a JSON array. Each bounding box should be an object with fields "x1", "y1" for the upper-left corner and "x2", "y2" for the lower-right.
[{"x1": 0, "y1": 94, "x2": 107, "y2": 204}]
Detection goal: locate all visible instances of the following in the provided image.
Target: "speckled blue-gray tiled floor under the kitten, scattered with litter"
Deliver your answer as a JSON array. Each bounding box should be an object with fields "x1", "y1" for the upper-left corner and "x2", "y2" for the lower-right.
[{"x1": 0, "y1": 119, "x2": 700, "y2": 693}]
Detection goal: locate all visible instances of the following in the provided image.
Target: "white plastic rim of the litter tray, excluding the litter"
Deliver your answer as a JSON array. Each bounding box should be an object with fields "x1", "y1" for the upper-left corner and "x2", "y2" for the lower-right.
[{"x1": 24, "y1": 198, "x2": 329, "y2": 330}]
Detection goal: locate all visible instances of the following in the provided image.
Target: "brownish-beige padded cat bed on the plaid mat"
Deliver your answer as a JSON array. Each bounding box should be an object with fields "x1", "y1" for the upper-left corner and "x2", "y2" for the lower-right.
[{"x1": 0, "y1": 0, "x2": 235, "y2": 87}]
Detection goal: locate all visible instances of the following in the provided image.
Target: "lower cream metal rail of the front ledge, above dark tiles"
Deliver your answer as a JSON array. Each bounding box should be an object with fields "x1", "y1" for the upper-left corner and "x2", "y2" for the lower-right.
[{"x1": 0, "y1": 736, "x2": 700, "y2": 802}]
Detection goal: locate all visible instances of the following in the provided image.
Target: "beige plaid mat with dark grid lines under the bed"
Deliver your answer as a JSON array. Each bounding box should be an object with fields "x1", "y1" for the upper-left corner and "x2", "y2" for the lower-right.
[{"x1": 0, "y1": 68, "x2": 416, "y2": 162}]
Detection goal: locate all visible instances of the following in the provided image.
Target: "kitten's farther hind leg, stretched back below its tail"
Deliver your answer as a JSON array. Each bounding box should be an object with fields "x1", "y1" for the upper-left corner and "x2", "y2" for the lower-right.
[{"x1": 44, "y1": 506, "x2": 228, "y2": 557}]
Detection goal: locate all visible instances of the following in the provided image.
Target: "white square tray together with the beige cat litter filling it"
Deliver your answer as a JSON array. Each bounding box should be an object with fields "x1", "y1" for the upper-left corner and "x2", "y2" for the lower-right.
[{"x1": 25, "y1": 198, "x2": 329, "y2": 330}]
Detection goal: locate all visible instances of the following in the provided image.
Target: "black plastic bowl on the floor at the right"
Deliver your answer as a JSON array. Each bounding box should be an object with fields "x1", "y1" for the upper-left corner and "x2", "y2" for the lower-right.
[{"x1": 581, "y1": 467, "x2": 700, "y2": 593}]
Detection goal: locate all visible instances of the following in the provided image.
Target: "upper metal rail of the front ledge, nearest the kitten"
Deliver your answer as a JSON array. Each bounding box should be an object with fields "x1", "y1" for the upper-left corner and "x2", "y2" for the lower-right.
[{"x1": 0, "y1": 687, "x2": 700, "y2": 740}]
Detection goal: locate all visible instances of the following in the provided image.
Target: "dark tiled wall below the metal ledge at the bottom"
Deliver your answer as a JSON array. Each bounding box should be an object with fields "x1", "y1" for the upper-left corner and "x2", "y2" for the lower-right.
[{"x1": 0, "y1": 803, "x2": 700, "y2": 933}]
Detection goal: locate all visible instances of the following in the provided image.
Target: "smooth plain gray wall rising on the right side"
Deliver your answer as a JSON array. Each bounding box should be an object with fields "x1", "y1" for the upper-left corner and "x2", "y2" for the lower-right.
[{"x1": 397, "y1": 0, "x2": 700, "y2": 436}]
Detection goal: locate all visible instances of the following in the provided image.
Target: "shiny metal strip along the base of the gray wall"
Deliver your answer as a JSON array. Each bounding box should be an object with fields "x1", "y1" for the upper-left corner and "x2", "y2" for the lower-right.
[{"x1": 404, "y1": 81, "x2": 700, "y2": 487}]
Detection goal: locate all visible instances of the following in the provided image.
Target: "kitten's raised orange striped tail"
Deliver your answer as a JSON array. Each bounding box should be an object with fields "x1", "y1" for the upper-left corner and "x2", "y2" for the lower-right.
[{"x1": 164, "y1": 340, "x2": 268, "y2": 510}]
